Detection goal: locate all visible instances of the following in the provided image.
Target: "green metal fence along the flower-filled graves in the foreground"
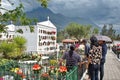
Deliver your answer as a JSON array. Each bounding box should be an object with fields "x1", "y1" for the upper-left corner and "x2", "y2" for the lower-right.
[{"x1": 0, "y1": 62, "x2": 85, "y2": 80}]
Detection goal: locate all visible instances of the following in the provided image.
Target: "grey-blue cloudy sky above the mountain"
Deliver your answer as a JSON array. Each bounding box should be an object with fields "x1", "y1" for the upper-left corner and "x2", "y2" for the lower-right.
[{"x1": 3, "y1": 0, "x2": 120, "y2": 24}]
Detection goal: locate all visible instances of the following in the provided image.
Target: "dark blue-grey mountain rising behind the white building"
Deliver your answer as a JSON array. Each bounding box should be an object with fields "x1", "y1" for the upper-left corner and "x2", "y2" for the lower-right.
[{"x1": 26, "y1": 7, "x2": 98, "y2": 30}]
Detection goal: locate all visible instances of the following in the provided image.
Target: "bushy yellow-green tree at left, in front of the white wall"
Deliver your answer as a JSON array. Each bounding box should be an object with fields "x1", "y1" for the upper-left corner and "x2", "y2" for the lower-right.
[{"x1": 0, "y1": 36, "x2": 26, "y2": 59}]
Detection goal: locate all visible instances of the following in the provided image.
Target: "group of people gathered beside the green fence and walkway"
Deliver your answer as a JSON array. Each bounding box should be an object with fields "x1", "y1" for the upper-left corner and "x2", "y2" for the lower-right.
[{"x1": 60, "y1": 36, "x2": 107, "y2": 80}]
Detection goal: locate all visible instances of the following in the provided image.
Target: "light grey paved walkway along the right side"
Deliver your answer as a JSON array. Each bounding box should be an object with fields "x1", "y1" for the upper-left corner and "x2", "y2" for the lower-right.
[{"x1": 83, "y1": 50, "x2": 120, "y2": 80}]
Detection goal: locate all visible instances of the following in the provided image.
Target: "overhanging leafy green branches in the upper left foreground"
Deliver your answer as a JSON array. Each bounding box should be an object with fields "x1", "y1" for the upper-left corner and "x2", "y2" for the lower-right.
[{"x1": 0, "y1": 0, "x2": 49, "y2": 32}]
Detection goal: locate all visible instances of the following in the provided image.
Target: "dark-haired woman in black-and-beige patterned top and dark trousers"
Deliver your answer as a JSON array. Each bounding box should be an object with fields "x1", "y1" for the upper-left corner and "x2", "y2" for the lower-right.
[{"x1": 88, "y1": 36, "x2": 102, "y2": 80}]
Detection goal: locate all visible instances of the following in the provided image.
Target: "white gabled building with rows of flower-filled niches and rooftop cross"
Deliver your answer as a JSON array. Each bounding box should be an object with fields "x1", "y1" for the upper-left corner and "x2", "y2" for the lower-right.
[{"x1": 0, "y1": 17, "x2": 57, "y2": 54}]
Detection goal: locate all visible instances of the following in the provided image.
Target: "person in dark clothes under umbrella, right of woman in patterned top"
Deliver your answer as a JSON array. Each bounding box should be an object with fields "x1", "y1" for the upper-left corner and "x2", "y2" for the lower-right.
[{"x1": 99, "y1": 41, "x2": 107, "y2": 80}]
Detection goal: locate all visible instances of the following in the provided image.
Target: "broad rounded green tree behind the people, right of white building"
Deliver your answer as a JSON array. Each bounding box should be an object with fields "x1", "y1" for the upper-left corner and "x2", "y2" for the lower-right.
[{"x1": 65, "y1": 23, "x2": 92, "y2": 41}]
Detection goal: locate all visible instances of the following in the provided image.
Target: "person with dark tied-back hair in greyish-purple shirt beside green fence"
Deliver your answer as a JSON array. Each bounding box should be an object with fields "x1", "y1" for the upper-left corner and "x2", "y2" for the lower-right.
[{"x1": 60, "y1": 45, "x2": 81, "y2": 71}]
